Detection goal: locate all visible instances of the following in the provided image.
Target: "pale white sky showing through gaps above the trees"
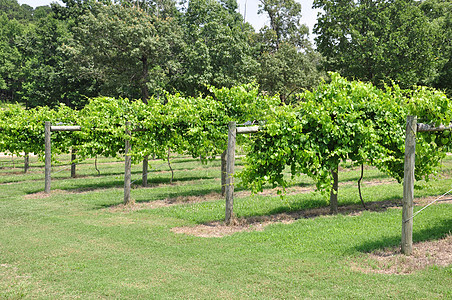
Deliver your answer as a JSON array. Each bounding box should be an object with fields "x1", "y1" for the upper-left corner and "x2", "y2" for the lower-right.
[{"x1": 18, "y1": 0, "x2": 319, "y2": 40}]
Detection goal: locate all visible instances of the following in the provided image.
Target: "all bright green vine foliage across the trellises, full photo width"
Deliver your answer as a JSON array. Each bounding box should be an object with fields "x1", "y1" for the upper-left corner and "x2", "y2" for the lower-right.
[{"x1": 0, "y1": 73, "x2": 452, "y2": 211}]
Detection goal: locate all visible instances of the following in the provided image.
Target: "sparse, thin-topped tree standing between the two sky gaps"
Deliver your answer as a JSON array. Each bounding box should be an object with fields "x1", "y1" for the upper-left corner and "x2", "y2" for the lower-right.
[{"x1": 257, "y1": 0, "x2": 322, "y2": 103}]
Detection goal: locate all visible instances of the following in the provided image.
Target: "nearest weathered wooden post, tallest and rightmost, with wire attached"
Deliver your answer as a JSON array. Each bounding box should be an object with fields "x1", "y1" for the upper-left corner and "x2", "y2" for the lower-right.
[{"x1": 402, "y1": 116, "x2": 417, "y2": 255}]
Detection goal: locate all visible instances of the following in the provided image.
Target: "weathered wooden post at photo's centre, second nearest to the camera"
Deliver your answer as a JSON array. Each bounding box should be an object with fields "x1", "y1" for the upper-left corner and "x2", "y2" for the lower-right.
[{"x1": 225, "y1": 122, "x2": 237, "y2": 225}]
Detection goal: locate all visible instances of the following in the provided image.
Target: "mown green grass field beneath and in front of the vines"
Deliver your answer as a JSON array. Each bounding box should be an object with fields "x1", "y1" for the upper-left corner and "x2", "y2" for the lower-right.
[{"x1": 0, "y1": 156, "x2": 452, "y2": 299}]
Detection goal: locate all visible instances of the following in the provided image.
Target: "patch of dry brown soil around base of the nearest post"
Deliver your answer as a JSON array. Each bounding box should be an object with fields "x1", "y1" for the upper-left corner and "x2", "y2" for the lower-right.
[{"x1": 351, "y1": 235, "x2": 452, "y2": 275}]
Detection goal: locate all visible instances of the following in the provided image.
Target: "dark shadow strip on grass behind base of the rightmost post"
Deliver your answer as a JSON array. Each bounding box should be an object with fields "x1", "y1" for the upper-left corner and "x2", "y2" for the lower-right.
[{"x1": 355, "y1": 218, "x2": 452, "y2": 253}]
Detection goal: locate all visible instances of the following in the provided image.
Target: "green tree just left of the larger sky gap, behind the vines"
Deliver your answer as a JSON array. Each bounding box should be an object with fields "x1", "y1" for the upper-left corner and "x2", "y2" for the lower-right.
[{"x1": 178, "y1": 0, "x2": 258, "y2": 96}]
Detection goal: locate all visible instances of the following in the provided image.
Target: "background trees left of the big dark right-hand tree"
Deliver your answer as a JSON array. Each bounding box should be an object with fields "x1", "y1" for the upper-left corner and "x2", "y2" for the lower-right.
[{"x1": 0, "y1": 0, "x2": 320, "y2": 108}]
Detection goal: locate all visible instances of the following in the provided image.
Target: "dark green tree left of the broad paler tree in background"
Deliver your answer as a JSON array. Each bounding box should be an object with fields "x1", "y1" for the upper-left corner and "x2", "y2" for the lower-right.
[{"x1": 18, "y1": 16, "x2": 97, "y2": 107}]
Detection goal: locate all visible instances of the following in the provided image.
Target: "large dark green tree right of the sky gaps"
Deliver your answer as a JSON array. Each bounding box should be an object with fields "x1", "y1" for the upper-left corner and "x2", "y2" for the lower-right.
[{"x1": 314, "y1": 0, "x2": 438, "y2": 88}]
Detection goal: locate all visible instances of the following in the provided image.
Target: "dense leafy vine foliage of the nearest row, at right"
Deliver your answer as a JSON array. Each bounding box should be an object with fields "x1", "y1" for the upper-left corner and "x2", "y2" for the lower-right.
[{"x1": 240, "y1": 73, "x2": 452, "y2": 198}]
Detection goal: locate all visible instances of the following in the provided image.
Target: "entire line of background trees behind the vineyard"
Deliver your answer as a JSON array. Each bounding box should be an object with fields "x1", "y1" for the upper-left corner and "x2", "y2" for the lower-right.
[{"x1": 0, "y1": 0, "x2": 452, "y2": 109}]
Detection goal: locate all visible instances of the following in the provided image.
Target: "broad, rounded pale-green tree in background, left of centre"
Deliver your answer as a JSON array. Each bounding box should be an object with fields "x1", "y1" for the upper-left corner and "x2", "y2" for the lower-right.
[{"x1": 66, "y1": 4, "x2": 182, "y2": 102}]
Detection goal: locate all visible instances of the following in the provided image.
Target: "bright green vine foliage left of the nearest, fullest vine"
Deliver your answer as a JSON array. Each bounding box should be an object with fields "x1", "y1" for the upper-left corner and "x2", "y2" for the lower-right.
[{"x1": 0, "y1": 84, "x2": 279, "y2": 162}]
